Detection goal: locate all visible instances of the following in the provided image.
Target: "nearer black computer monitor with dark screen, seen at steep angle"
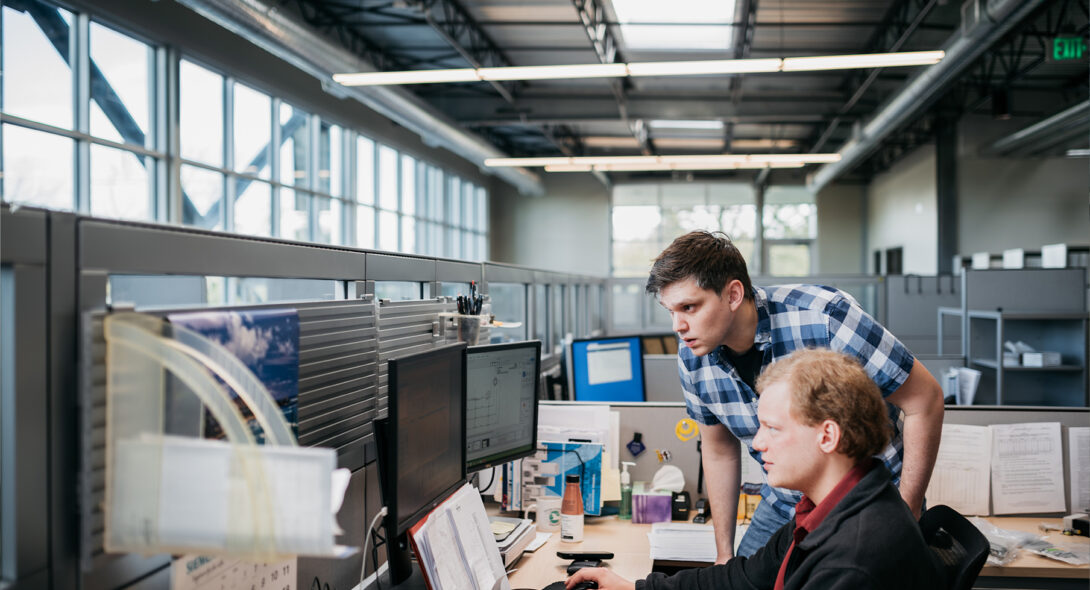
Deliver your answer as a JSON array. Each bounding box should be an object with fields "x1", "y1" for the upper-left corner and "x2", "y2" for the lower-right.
[{"x1": 386, "y1": 345, "x2": 465, "y2": 534}]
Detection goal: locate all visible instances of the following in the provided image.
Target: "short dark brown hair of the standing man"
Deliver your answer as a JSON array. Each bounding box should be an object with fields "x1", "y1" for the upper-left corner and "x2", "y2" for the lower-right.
[{"x1": 646, "y1": 231, "x2": 753, "y2": 299}]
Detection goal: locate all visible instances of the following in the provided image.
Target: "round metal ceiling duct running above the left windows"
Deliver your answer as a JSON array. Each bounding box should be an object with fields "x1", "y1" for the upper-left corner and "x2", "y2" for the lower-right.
[{"x1": 178, "y1": 0, "x2": 545, "y2": 196}]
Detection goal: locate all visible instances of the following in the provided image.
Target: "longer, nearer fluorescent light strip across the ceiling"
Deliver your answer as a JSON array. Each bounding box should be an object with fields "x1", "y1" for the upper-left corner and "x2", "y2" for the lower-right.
[{"x1": 334, "y1": 51, "x2": 945, "y2": 86}]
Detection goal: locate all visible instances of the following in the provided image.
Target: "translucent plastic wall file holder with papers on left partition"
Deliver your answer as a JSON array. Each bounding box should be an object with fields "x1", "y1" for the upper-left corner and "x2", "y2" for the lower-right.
[{"x1": 104, "y1": 313, "x2": 349, "y2": 561}]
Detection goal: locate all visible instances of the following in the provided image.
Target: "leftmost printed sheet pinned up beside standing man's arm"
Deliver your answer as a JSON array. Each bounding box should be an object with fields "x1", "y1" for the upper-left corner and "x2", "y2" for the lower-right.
[{"x1": 927, "y1": 424, "x2": 992, "y2": 516}]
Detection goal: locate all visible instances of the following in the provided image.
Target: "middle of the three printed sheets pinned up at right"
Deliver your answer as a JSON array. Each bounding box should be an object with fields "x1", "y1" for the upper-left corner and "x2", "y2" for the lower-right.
[{"x1": 991, "y1": 422, "x2": 1066, "y2": 515}]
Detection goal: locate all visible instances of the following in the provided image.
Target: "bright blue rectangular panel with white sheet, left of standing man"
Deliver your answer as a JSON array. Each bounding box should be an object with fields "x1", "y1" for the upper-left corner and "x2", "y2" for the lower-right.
[{"x1": 571, "y1": 336, "x2": 644, "y2": 401}]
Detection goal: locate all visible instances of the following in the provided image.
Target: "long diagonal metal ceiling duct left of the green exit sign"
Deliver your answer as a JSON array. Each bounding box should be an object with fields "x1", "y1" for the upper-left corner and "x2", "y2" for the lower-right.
[{"x1": 807, "y1": 0, "x2": 1043, "y2": 192}]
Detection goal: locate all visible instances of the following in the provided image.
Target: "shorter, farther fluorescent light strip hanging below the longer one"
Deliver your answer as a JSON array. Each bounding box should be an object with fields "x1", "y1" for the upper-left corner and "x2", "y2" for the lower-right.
[{"x1": 484, "y1": 154, "x2": 840, "y2": 168}]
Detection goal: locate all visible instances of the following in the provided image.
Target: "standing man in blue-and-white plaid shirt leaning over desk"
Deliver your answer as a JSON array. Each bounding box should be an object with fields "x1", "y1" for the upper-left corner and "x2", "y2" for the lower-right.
[{"x1": 646, "y1": 231, "x2": 943, "y2": 564}]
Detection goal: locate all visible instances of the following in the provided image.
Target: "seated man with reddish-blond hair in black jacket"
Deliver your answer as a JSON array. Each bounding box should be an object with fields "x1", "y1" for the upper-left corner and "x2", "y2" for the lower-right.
[{"x1": 567, "y1": 349, "x2": 944, "y2": 590}]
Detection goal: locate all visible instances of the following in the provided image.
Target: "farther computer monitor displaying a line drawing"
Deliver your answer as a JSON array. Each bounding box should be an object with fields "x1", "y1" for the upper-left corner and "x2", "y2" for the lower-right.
[{"x1": 465, "y1": 340, "x2": 542, "y2": 471}]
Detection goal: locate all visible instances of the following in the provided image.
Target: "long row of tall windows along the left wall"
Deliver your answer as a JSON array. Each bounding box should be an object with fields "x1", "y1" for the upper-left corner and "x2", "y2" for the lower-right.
[{"x1": 0, "y1": 0, "x2": 488, "y2": 260}]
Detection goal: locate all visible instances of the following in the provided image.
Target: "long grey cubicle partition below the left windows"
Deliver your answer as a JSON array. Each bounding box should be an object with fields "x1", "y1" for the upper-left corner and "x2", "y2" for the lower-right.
[{"x1": 0, "y1": 205, "x2": 603, "y2": 589}]
